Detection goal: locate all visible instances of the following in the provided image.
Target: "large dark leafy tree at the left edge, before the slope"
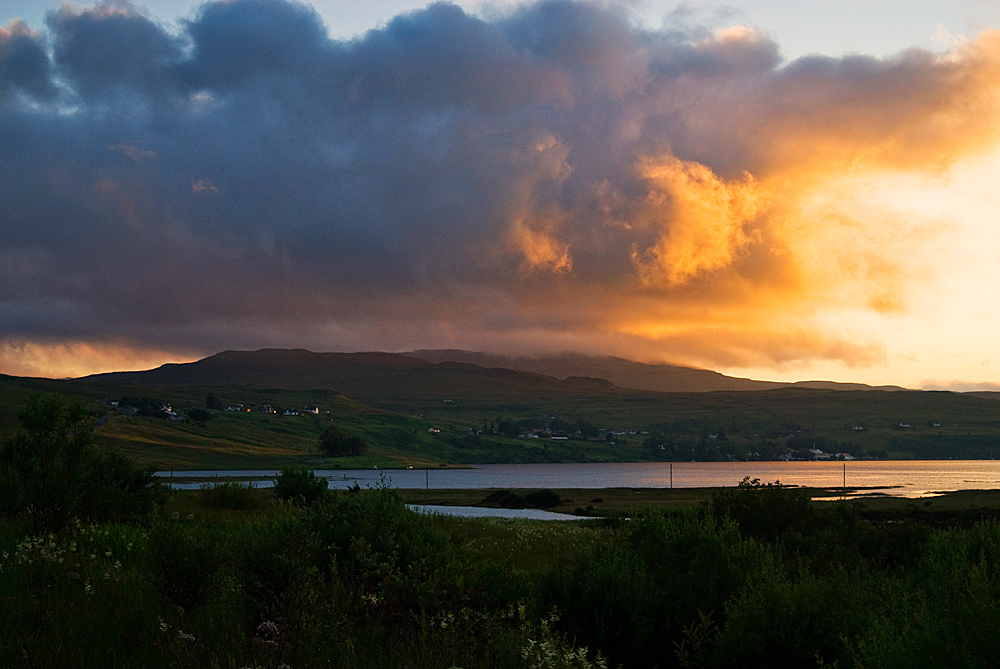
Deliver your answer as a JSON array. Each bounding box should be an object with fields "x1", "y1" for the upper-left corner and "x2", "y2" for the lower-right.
[{"x1": 0, "y1": 393, "x2": 159, "y2": 532}]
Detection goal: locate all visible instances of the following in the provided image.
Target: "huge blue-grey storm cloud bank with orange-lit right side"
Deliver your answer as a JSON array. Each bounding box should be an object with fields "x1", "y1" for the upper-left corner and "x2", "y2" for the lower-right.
[{"x1": 0, "y1": 0, "x2": 996, "y2": 376}]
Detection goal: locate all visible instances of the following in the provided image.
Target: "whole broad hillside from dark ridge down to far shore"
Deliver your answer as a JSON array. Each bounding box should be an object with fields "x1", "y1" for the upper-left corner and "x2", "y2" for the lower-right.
[{"x1": 0, "y1": 351, "x2": 1000, "y2": 469}]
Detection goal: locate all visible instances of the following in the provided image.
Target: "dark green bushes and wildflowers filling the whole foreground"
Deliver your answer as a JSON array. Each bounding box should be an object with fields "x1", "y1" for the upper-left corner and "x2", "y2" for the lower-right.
[{"x1": 0, "y1": 398, "x2": 1000, "y2": 669}]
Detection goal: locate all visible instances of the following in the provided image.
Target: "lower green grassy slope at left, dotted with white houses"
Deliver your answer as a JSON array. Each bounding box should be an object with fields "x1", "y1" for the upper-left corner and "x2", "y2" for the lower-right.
[{"x1": 0, "y1": 376, "x2": 656, "y2": 470}]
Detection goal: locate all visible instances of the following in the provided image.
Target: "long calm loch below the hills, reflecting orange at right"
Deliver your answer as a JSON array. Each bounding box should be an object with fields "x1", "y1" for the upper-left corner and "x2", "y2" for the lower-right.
[{"x1": 157, "y1": 460, "x2": 1000, "y2": 497}]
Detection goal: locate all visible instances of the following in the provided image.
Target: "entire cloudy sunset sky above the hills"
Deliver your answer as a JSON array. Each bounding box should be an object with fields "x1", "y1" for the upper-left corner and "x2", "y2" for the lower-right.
[{"x1": 0, "y1": 0, "x2": 1000, "y2": 390}]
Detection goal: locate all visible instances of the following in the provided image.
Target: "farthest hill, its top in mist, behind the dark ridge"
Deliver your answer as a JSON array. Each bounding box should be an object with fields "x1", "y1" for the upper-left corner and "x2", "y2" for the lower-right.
[{"x1": 404, "y1": 349, "x2": 903, "y2": 393}]
